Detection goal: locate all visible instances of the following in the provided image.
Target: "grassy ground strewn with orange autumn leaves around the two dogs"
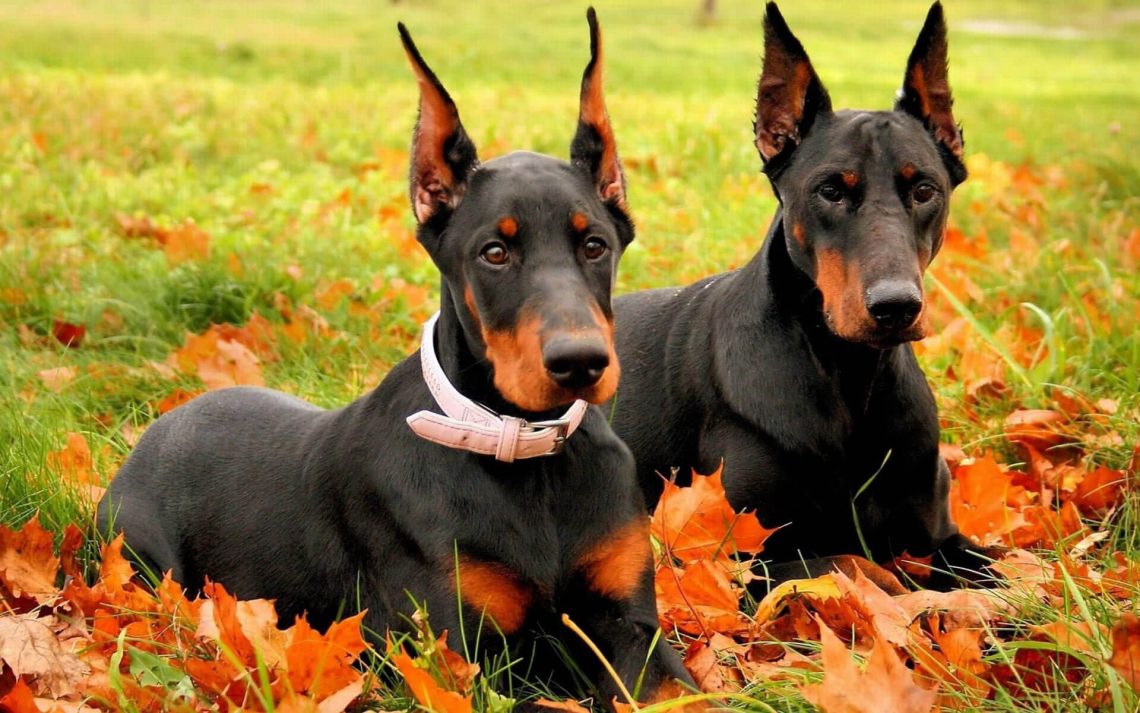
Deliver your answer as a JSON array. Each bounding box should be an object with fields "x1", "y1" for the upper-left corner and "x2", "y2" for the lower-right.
[{"x1": 0, "y1": 0, "x2": 1140, "y2": 713}]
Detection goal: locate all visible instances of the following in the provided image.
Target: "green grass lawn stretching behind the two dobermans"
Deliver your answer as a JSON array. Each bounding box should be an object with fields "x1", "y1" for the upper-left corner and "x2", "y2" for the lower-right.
[{"x1": 0, "y1": 0, "x2": 1140, "y2": 710}]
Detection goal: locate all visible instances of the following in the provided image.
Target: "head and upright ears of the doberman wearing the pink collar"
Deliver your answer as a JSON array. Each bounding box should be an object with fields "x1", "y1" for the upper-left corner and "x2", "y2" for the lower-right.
[{"x1": 400, "y1": 8, "x2": 634, "y2": 412}]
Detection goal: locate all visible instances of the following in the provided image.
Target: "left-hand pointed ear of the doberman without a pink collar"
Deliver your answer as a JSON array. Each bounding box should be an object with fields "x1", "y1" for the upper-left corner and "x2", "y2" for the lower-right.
[{"x1": 755, "y1": 2, "x2": 831, "y2": 164}]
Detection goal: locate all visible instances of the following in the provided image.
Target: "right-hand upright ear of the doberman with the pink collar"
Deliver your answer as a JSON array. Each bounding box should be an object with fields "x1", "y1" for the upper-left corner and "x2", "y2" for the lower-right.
[{"x1": 570, "y1": 8, "x2": 626, "y2": 211}]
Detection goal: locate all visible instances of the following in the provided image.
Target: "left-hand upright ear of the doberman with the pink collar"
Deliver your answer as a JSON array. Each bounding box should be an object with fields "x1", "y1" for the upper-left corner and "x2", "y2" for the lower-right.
[{"x1": 398, "y1": 23, "x2": 479, "y2": 224}]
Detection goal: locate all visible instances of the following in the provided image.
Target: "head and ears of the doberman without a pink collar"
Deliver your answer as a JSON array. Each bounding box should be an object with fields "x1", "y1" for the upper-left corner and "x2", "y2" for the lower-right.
[{"x1": 756, "y1": 2, "x2": 966, "y2": 347}]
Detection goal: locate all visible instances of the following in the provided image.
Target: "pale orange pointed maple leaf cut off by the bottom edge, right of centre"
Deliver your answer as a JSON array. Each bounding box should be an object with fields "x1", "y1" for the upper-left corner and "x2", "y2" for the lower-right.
[{"x1": 799, "y1": 623, "x2": 937, "y2": 713}]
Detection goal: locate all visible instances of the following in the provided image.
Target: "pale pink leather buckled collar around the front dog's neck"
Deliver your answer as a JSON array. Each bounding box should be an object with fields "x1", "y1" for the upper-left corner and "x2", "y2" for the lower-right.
[{"x1": 408, "y1": 313, "x2": 589, "y2": 463}]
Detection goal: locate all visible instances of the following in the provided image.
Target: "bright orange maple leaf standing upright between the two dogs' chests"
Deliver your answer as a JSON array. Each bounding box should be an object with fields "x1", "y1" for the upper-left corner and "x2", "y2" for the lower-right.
[{"x1": 650, "y1": 464, "x2": 775, "y2": 562}]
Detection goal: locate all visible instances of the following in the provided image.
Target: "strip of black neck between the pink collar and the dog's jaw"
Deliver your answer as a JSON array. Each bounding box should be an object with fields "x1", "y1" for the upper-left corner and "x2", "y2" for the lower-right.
[{"x1": 435, "y1": 281, "x2": 564, "y2": 421}]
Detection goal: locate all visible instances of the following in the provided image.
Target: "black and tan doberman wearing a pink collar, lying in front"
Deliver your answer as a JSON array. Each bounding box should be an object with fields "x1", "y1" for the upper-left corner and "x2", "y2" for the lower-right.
[{"x1": 99, "y1": 9, "x2": 692, "y2": 703}]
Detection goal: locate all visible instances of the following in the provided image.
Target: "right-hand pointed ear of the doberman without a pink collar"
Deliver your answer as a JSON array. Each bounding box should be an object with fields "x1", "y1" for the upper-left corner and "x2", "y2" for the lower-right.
[{"x1": 895, "y1": 2, "x2": 966, "y2": 186}]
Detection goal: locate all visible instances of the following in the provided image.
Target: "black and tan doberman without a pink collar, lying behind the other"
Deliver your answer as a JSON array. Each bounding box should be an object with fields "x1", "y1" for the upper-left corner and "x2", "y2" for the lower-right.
[{"x1": 613, "y1": 2, "x2": 986, "y2": 586}]
